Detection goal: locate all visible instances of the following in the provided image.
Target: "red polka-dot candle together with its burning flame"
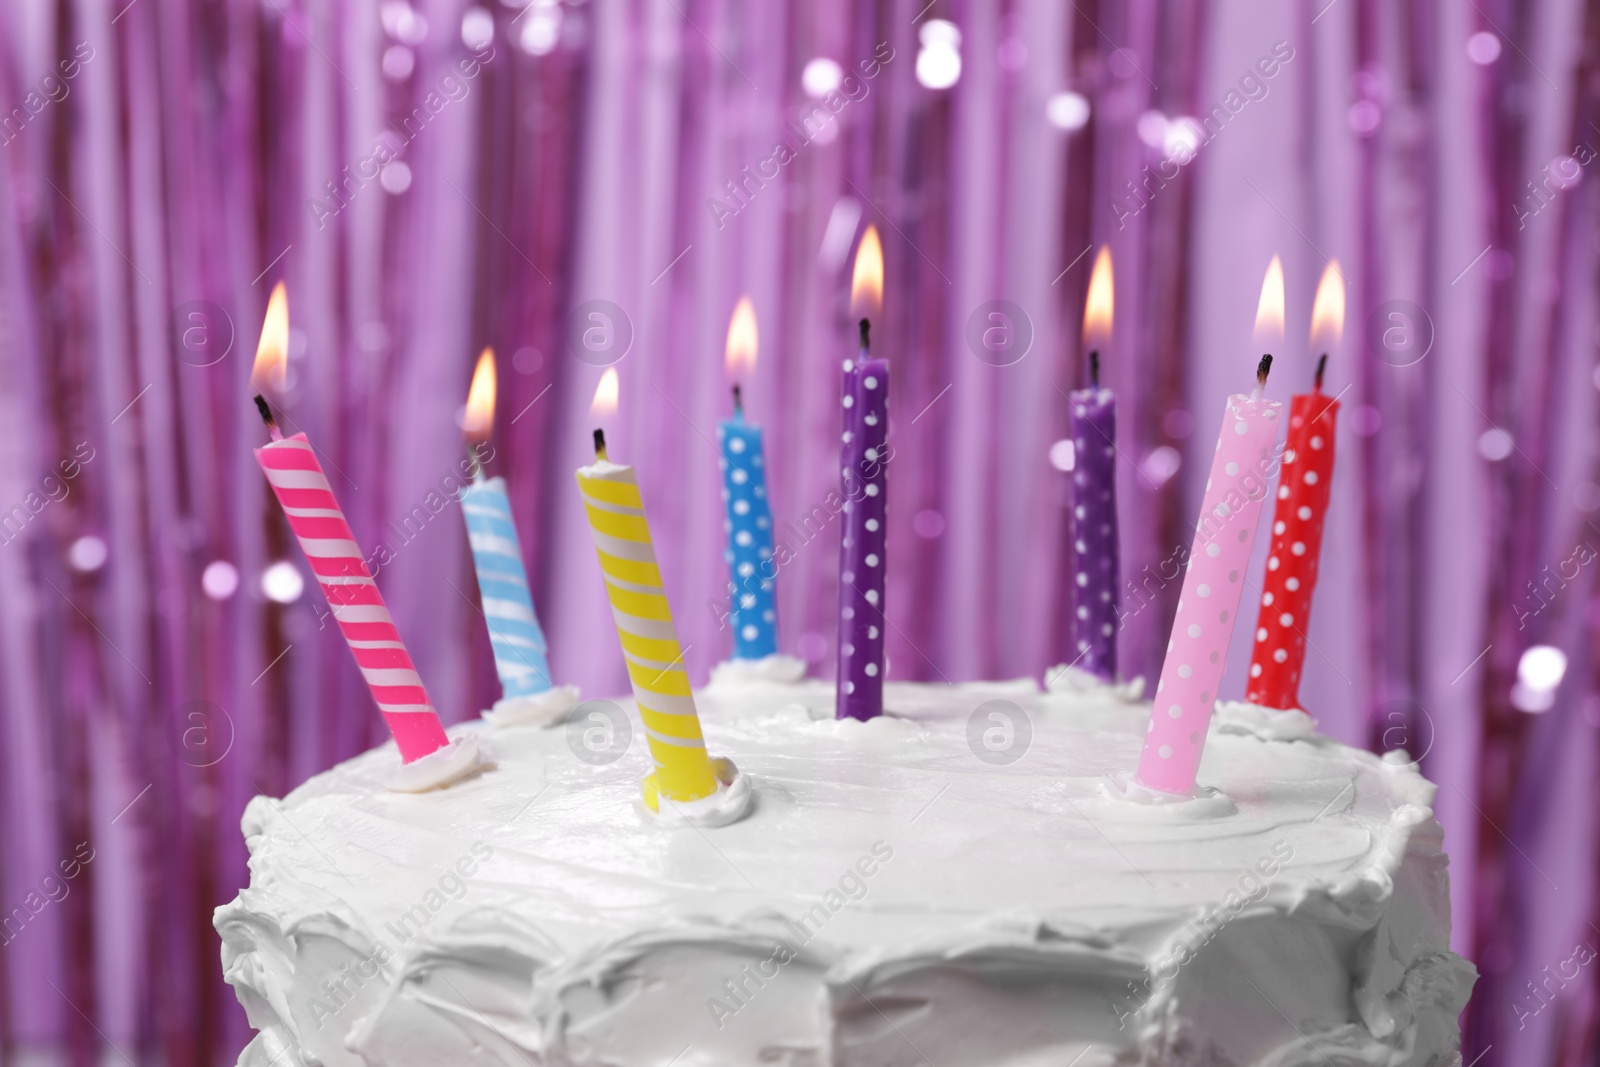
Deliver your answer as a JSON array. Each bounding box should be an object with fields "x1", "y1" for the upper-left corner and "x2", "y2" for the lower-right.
[{"x1": 1245, "y1": 262, "x2": 1344, "y2": 709}]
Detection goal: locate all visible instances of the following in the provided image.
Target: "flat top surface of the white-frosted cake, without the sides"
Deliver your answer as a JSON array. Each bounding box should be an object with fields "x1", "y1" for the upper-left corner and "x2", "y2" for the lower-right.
[{"x1": 240, "y1": 680, "x2": 1437, "y2": 968}]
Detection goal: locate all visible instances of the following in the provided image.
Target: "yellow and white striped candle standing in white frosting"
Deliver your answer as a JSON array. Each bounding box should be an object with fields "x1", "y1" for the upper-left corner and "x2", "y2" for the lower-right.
[{"x1": 578, "y1": 432, "x2": 733, "y2": 811}]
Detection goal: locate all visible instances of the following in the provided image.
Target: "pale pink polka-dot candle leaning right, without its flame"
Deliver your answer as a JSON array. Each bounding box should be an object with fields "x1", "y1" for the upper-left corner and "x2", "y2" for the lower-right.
[{"x1": 1138, "y1": 355, "x2": 1283, "y2": 793}]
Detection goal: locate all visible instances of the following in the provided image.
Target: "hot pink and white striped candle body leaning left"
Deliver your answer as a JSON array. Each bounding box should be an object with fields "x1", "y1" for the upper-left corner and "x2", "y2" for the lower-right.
[{"x1": 256, "y1": 434, "x2": 448, "y2": 763}]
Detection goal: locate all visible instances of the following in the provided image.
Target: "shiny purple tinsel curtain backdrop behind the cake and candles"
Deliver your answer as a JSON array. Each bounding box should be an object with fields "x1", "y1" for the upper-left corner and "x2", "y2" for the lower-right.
[{"x1": 0, "y1": 0, "x2": 1600, "y2": 1067}]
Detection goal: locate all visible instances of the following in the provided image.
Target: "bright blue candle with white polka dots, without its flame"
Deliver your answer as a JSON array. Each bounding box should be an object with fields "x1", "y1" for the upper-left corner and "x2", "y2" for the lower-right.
[{"x1": 717, "y1": 386, "x2": 778, "y2": 659}]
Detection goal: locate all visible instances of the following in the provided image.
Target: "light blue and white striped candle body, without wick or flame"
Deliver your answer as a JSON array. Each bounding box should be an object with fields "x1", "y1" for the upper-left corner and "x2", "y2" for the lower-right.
[{"x1": 461, "y1": 478, "x2": 550, "y2": 699}]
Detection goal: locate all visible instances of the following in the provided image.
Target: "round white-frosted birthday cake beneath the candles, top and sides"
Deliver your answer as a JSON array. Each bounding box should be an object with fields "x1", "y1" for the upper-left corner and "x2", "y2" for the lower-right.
[{"x1": 216, "y1": 680, "x2": 1475, "y2": 1067}]
